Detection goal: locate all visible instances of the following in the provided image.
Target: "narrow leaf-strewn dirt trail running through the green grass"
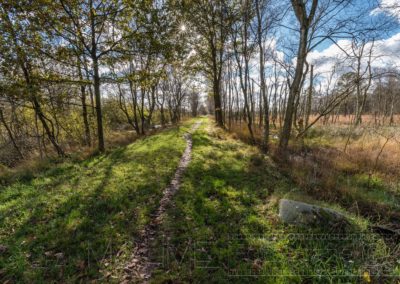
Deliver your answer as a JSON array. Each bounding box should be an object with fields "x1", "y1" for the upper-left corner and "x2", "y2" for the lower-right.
[{"x1": 121, "y1": 121, "x2": 201, "y2": 284}]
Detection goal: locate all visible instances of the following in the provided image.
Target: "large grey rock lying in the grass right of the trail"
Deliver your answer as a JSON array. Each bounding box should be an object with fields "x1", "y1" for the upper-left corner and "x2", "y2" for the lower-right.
[{"x1": 279, "y1": 199, "x2": 349, "y2": 228}]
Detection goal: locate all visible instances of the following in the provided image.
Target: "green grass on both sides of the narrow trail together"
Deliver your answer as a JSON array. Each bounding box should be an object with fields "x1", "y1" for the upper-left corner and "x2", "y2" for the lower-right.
[{"x1": 0, "y1": 118, "x2": 400, "y2": 283}]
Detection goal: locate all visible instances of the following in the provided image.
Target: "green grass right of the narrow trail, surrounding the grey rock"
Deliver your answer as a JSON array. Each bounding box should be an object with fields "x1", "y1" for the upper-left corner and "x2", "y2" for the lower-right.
[{"x1": 154, "y1": 118, "x2": 398, "y2": 283}]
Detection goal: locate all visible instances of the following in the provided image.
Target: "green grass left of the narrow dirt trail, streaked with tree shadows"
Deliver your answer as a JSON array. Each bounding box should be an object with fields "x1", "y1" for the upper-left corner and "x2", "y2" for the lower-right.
[{"x1": 0, "y1": 122, "x2": 191, "y2": 283}]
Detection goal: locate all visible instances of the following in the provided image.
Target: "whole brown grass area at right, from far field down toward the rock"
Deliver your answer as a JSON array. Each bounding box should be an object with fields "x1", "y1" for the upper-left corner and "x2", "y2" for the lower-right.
[{"x1": 225, "y1": 120, "x2": 400, "y2": 225}]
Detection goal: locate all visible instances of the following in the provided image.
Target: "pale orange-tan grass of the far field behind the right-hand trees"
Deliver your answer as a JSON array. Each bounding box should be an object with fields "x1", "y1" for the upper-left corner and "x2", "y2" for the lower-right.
[{"x1": 229, "y1": 119, "x2": 400, "y2": 177}]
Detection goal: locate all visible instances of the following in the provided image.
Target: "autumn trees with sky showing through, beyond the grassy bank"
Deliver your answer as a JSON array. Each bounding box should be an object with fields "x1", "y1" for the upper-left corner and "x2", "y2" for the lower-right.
[{"x1": 0, "y1": 0, "x2": 400, "y2": 166}]
